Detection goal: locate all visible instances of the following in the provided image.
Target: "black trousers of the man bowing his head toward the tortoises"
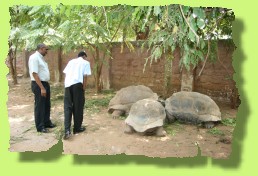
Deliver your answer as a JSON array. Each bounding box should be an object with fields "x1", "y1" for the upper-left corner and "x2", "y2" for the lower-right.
[{"x1": 64, "y1": 83, "x2": 85, "y2": 132}]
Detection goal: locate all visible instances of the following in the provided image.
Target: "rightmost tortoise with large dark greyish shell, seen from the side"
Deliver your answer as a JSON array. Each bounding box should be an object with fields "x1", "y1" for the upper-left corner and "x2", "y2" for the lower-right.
[{"x1": 165, "y1": 91, "x2": 221, "y2": 128}]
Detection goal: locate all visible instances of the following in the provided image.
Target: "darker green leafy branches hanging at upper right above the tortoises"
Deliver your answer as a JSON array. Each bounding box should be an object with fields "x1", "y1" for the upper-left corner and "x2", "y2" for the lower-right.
[{"x1": 134, "y1": 5, "x2": 234, "y2": 70}]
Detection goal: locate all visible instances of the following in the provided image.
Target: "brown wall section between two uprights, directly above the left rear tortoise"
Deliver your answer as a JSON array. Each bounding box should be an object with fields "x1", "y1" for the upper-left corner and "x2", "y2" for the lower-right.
[{"x1": 110, "y1": 41, "x2": 164, "y2": 92}]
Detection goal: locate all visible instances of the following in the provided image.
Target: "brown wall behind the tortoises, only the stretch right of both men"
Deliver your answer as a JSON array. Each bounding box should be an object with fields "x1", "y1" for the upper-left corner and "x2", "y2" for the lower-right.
[{"x1": 110, "y1": 41, "x2": 235, "y2": 99}]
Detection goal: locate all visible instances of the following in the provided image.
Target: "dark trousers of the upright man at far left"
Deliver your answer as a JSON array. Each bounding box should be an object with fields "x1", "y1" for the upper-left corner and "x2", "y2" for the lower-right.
[{"x1": 31, "y1": 81, "x2": 51, "y2": 131}]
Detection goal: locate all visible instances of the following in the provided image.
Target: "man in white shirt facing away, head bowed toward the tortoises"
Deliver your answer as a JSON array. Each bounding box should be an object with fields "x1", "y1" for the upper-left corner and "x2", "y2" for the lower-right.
[{"x1": 63, "y1": 51, "x2": 91, "y2": 139}]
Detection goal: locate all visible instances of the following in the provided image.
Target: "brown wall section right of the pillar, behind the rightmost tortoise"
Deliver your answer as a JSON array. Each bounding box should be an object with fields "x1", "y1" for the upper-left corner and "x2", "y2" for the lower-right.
[{"x1": 195, "y1": 41, "x2": 235, "y2": 99}]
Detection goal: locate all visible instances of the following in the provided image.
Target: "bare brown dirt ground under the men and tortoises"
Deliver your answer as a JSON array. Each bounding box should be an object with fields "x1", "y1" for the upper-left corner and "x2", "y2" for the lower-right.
[{"x1": 7, "y1": 78, "x2": 237, "y2": 159}]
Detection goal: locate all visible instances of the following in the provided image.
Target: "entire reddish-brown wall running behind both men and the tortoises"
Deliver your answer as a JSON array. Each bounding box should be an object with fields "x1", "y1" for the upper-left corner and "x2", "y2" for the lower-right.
[{"x1": 13, "y1": 41, "x2": 235, "y2": 98}]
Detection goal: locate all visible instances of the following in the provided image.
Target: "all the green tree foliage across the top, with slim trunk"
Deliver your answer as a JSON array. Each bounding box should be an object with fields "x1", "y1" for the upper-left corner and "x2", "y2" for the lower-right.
[{"x1": 8, "y1": 4, "x2": 234, "y2": 92}]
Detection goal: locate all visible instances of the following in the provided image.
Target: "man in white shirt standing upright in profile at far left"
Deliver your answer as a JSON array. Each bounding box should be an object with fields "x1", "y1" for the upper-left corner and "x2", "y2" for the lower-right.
[{"x1": 29, "y1": 43, "x2": 56, "y2": 133}]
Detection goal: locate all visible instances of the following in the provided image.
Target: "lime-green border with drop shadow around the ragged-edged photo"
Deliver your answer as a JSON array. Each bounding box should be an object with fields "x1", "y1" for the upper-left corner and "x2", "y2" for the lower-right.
[{"x1": 0, "y1": 0, "x2": 258, "y2": 176}]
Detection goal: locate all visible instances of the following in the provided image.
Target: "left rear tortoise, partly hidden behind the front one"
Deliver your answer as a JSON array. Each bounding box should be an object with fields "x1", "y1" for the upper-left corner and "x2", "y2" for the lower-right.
[{"x1": 108, "y1": 85, "x2": 158, "y2": 118}]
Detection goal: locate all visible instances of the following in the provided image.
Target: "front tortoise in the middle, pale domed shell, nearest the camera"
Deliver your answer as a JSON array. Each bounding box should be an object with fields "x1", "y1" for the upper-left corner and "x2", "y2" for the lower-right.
[{"x1": 124, "y1": 99, "x2": 166, "y2": 136}]
